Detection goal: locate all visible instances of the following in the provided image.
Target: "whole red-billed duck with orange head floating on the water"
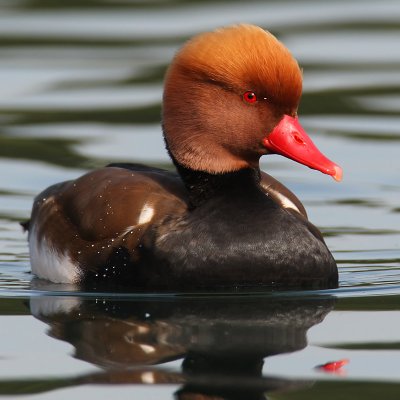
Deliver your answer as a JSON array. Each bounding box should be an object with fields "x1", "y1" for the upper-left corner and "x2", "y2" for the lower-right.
[{"x1": 24, "y1": 24, "x2": 342, "y2": 292}]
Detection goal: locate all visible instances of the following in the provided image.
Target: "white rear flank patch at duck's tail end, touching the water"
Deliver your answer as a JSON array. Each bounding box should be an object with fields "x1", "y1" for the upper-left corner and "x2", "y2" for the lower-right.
[{"x1": 29, "y1": 227, "x2": 82, "y2": 283}]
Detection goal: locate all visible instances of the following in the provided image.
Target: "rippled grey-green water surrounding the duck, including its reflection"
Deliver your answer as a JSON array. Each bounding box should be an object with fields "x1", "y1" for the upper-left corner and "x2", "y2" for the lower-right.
[{"x1": 0, "y1": 0, "x2": 400, "y2": 399}]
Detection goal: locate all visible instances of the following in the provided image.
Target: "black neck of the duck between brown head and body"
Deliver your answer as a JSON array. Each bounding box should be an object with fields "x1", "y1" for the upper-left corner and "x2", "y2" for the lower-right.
[{"x1": 171, "y1": 156, "x2": 261, "y2": 208}]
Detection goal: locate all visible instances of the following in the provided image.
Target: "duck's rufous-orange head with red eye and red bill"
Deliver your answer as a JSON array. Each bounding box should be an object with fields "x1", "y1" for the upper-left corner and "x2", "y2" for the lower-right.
[{"x1": 163, "y1": 25, "x2": 342, "y2": 180}]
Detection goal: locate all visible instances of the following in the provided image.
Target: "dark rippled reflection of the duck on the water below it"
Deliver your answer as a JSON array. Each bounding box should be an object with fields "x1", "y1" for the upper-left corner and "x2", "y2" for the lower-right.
[{"x1": 31, "y1": 295, "x2": 334, "y2": 400}]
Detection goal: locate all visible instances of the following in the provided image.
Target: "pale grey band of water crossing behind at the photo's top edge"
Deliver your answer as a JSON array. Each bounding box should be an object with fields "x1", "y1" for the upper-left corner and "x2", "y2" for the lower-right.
[{"x1": 0, "y1": 0, "x2": 400, "y2": 40}]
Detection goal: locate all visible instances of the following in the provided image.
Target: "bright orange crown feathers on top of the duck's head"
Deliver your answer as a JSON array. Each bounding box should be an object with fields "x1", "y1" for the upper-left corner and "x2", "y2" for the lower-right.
[{"x1": 170, "y1": 24, "x2": 302, "y2": 106}]
